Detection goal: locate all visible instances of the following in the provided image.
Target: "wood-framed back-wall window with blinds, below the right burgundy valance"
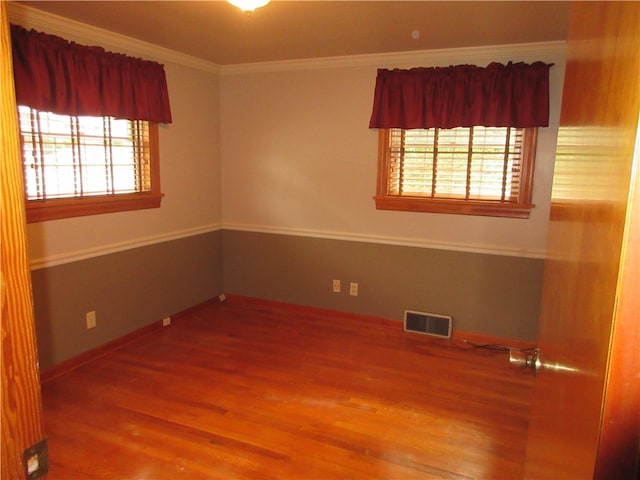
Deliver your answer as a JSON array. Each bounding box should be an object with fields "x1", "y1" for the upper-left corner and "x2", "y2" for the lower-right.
[{"x1": 375, "y1": 127, "x2": 537, "y2": 218}]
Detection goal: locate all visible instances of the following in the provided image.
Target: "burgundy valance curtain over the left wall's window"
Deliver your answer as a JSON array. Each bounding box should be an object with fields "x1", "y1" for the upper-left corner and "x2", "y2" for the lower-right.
[{"x1": 11, "y1": 25, "x2": 171, "y2": 123}]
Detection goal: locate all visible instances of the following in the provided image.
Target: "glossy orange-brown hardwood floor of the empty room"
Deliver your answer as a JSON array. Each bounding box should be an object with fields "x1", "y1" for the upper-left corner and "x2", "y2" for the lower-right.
[{"x1": 42, "y1": 299, "x2": 532, "y2": 480}]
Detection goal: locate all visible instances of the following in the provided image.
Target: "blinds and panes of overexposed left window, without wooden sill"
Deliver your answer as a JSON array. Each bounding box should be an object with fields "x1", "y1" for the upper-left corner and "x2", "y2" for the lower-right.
[{"x1": 19, "y1": 106, "x2": 150, "y2": 200}]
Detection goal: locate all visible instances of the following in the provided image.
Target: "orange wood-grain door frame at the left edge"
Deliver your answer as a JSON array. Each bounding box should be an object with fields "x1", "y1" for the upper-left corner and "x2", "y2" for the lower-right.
[{"x1": 0, "y1": 2, "x2": 44, "y2": 479}]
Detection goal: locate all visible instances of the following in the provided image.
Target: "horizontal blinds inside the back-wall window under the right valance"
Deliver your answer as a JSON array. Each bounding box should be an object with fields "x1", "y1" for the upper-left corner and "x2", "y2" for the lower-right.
[{"x1": 388, "y1": 127, "x2": 523, "y2": 202}]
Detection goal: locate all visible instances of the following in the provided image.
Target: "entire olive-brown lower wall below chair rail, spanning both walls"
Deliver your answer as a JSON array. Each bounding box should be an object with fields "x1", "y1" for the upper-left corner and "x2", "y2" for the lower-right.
[{"x1": 32, "y1": 230, "x2": 544, "y2": 370}]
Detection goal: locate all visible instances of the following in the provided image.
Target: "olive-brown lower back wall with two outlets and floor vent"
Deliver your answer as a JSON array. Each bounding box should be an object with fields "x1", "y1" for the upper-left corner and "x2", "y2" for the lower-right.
[{"x1": 222, "y1": 230, "x2": 544, "y2": 342}]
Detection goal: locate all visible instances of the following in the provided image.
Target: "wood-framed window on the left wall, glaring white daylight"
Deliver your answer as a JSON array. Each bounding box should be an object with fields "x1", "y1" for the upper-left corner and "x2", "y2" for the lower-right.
[{"x1": 18, "y1": 106, "x2": 162, "y2": 222}]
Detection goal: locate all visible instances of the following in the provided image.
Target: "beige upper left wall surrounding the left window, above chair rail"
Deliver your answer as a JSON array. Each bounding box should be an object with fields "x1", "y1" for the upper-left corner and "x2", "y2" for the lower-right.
[{"x1": 9, "y1": 5, "x2": 222, "y2": 268}]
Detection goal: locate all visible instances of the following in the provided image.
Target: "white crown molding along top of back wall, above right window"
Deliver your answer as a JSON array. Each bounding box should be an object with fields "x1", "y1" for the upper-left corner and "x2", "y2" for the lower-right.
[{"x1": 220, "y1": 41, "x2": 567, "y2": 75}]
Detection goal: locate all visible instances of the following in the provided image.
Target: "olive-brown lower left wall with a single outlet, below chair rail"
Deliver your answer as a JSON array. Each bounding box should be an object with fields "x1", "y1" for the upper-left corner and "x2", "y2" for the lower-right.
[{"x1": 31, "y1": 231, "x2": 222, "y2": 370}]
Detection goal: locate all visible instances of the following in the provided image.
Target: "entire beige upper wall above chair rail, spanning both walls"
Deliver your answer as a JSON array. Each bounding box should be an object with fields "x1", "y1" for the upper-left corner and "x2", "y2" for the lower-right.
[{"x1": 9, "y1": 6, "x2": 564, "y2": 268}]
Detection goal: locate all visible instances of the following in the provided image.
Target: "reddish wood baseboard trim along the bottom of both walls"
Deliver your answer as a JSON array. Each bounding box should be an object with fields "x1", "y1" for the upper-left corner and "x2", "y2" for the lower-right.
[{"x1": 40, "y1": 293, "x2": 535, "y2": 384}]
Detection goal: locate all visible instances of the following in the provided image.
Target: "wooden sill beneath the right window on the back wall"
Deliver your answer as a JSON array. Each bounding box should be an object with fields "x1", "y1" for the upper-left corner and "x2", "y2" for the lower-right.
[{"x1": 373, "y1": 196, "x2": 535, "y2": 218}]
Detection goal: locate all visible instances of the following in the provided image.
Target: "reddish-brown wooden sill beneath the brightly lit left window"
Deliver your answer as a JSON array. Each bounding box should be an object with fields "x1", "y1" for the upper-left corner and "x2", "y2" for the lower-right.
[{"x1": 27, "y1": 193, "x2": 164, "y2": 223}]
